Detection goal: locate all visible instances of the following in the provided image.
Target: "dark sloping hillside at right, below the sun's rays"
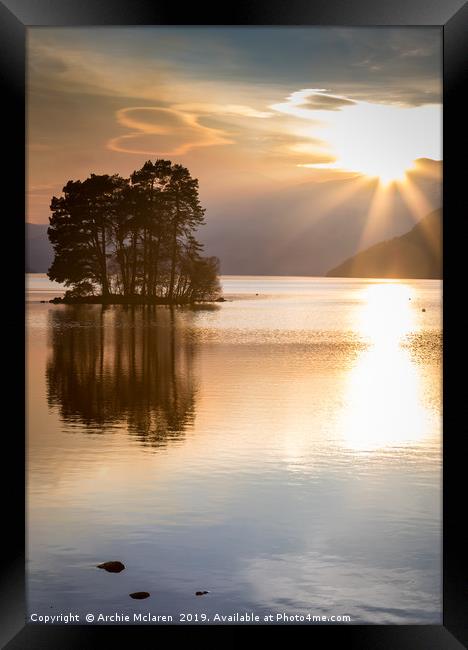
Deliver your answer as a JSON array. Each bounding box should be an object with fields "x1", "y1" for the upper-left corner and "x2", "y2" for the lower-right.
[{"x1": 327, "y1": 210, "x2": 442, "y2": 278}]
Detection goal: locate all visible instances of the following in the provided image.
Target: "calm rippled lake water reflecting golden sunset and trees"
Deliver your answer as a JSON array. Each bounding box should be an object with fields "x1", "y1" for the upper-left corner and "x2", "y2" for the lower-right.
[{"x1": 27, "y1": 275, "x2": 442, "y2": 624}]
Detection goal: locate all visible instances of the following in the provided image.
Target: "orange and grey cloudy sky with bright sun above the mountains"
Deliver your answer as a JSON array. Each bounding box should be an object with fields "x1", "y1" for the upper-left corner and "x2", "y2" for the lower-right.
[{"x1": 26, "y1": 27, "x2": 442, "y2": 230}]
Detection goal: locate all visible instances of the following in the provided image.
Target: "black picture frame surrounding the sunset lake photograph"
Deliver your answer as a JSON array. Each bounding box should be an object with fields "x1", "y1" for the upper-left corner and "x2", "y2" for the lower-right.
[{"x1": 4, "y1": 0, "x2": 468, "y2": 650}]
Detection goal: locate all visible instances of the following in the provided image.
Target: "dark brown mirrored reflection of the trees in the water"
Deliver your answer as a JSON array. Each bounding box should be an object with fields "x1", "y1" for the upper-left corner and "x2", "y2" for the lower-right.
[{"x1": 46, "y1": 305, "x2": 196, "y2": 446}]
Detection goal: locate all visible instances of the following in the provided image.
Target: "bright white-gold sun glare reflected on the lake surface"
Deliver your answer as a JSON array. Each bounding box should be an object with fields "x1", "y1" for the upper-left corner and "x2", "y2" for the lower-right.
[{"x1": 341, "y1": 283, "x2": 438, "y2": 452}]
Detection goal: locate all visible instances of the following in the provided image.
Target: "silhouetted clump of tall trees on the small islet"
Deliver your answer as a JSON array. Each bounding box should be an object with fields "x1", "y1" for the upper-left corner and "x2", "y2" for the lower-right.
[{"x1": 47, "y1": 159, "x2": 220, "y2": 303}]
